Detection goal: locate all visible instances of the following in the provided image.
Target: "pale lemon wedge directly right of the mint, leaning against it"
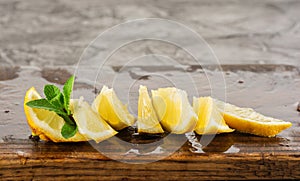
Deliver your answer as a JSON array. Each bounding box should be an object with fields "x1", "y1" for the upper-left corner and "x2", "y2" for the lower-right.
[{"x1": 70, "y1": 97, "x2": 117, "y2": 143}]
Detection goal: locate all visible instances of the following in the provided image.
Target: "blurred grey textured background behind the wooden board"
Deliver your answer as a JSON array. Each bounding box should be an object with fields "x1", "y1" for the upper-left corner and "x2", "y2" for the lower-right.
[{"x1": 0, "y1": 0, "x2": 300, "y2": 67}]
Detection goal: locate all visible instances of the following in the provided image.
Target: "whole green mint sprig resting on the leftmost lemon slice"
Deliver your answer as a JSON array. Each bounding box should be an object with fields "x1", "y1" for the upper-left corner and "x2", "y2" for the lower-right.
[{"x1": 26, "y1": 76, "x2": 78, "y2": 139}]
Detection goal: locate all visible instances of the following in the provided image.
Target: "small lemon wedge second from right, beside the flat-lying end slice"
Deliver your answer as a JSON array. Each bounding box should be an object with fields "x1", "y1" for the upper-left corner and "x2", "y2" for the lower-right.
[{"x1": 193, "y1": 97, "x2": 234, "y2": 134}]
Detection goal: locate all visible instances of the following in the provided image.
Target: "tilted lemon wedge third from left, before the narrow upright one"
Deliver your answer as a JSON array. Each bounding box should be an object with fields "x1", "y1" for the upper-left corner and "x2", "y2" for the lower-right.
[{"x1": 92, "y1": 86, "x2": 135, "y2": 130}]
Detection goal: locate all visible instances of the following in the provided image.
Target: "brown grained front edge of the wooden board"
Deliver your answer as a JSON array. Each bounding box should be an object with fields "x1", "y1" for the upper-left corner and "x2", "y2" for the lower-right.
[{"x1": 0, "y1": 137, "x2": 300, "y2": 180}]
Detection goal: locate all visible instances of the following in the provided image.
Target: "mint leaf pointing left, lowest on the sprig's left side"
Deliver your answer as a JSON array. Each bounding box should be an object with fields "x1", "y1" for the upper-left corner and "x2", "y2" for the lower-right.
[{"x1": 26, "y1": 99, "x2": 66, "y2": 115}]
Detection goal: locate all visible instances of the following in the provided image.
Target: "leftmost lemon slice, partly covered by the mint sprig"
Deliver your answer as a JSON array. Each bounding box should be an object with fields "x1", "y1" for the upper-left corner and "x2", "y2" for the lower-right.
[{"x1": 24, "y1": 87, "x2": 86, "y2": 142}]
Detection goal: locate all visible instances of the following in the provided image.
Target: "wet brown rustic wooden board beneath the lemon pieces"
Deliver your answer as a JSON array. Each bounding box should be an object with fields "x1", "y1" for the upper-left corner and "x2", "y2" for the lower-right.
[{"x1": 0, "y1": 65, "x2": 300, "y2": 180}]
